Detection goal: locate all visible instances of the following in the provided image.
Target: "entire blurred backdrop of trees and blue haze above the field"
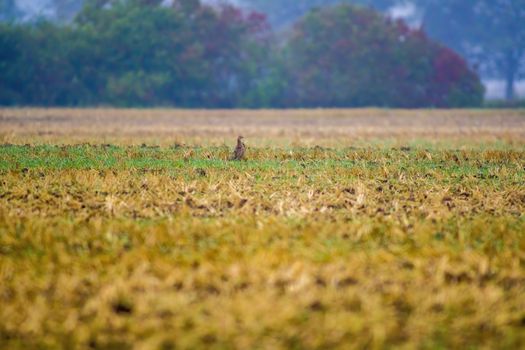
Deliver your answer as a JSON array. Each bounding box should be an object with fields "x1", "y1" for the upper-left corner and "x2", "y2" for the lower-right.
[{"x1": 0, "y1": 0, "x2": 525, "y2": 108}]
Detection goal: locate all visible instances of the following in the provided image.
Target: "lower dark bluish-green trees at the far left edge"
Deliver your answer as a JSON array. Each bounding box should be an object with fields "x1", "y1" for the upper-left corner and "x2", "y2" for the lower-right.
[{"x1": 0, "y1": 23, "x2": 85, "y2": 105}]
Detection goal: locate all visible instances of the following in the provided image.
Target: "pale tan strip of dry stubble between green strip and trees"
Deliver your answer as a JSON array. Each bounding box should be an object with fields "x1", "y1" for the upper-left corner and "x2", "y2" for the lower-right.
[{"x1": 0, "y1": 109, "x2": 525, "y2": 147}]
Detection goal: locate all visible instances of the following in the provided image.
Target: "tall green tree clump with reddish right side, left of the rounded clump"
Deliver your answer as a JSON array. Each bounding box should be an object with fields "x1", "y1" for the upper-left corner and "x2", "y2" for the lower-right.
[{"x1": 72, "y1": 0, "x2": 266, "y2": 107}]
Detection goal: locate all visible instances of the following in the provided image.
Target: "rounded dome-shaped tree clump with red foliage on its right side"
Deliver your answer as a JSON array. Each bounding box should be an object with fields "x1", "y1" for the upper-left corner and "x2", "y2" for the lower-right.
[{"x1": 285, "y1": 5, "x2": 483, "y2": 107}]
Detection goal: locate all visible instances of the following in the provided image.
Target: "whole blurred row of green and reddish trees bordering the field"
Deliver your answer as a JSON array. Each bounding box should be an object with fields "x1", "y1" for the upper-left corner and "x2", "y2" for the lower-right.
[{"x1": 0, "y1": 0, "x2": 483, "y2": 108}]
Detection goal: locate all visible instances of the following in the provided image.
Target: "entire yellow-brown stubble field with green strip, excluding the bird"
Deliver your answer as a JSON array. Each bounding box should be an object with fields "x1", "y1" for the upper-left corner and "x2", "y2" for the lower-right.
[{"x1": 0, "y1": 109, "x2": 525, "y2": 349}]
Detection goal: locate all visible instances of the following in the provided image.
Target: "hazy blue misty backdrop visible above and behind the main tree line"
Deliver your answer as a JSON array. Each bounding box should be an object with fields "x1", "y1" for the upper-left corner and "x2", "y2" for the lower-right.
[{"x1": 0, "y1": 0, "x2": 525, "y2": 105}]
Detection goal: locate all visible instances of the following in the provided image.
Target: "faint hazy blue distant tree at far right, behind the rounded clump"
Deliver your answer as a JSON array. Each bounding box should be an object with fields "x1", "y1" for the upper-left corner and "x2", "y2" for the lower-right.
[{"x1": 419, "y1": 0, "x2": 525, "y2": 100}]
